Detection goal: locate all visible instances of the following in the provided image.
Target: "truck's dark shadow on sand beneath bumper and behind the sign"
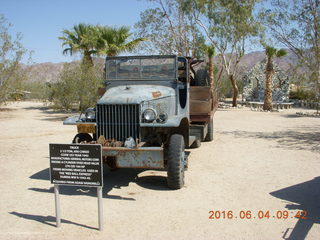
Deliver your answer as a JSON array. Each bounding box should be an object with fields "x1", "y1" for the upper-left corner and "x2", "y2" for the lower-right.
[{"x1": 29, "y1": 168, "x2": 171, "y2": 201}]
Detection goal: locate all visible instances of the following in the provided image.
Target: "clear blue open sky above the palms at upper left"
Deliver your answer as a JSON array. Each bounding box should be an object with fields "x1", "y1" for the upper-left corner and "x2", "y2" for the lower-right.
[{"x1": 0, "y1": 0, "x2": 151, "y2": 63}]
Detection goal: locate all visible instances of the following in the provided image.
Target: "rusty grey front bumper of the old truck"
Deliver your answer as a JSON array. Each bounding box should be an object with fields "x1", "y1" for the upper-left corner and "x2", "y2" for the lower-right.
[{"x1": 102, "y1": 147, "x2": 164, "y2": 169}]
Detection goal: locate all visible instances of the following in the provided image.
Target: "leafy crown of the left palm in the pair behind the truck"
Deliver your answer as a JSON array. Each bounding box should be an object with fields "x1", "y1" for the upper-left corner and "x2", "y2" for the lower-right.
[{"x1": 59, "y1": 23, "x2": 98, "y2": 66}]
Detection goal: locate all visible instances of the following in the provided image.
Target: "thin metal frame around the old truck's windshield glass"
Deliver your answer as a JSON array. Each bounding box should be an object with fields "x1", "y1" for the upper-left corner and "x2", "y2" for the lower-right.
[{"x1": 104, "y1": 55, "x2": 178, "y2": 82}]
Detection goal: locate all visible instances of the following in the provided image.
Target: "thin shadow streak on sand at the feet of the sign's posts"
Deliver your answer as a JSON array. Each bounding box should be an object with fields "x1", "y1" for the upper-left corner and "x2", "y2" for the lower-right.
[{"x1": 9, "y1": 212, "x2": 98, "y2": 230}]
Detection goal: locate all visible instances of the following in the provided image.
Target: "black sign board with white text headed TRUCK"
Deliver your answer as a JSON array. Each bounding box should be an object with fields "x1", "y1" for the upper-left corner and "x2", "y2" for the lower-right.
[{"x1": 49, "y1": 144, "x2": 103, "y2": 187}]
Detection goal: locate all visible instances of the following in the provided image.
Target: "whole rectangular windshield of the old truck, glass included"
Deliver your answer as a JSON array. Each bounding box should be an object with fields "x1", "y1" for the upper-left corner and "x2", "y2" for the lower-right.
[{"x1": 106, "y1": 57, "x2": 175, "y2": 80}]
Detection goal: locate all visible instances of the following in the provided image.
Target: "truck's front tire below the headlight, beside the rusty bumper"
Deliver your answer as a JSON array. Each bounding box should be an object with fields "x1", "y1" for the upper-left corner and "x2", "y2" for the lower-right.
[{"x1": 166, "y1": 134, "x2": 185, "y2": 189}]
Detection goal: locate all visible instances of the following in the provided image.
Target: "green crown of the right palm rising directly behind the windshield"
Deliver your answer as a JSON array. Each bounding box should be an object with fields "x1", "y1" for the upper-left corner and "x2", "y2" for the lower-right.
[{"x1": 97, "y1": 26, "x2": 146, "y2": 56}]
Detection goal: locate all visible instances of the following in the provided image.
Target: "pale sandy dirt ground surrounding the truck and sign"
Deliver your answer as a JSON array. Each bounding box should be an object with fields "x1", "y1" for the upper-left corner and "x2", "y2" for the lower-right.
[{"x1": 0, "y1": 102, "x2": 320, "y2": 240}]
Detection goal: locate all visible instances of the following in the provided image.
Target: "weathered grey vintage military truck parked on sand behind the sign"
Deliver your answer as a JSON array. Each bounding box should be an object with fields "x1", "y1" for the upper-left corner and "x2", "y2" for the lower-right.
[{"x1": 64, "y1": 55, "x2": 217, "y2": 189}]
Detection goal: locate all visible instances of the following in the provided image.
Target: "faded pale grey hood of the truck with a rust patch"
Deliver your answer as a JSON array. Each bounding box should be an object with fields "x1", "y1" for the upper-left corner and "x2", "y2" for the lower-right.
[{"x1": 98, "y1": 85, "x2": 175, "y2": 104}]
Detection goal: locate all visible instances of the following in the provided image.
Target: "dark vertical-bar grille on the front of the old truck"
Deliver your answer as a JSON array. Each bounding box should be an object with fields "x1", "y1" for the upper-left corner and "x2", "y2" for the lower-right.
[{"x1": 97, "y1": 104, "x2": 140, "y2": 141}]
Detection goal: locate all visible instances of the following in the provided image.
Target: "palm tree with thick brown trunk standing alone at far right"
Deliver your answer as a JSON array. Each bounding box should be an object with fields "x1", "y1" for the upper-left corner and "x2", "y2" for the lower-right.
[{"x1": 263, "y1": 46, "x2": 287, "y2": 111}]
